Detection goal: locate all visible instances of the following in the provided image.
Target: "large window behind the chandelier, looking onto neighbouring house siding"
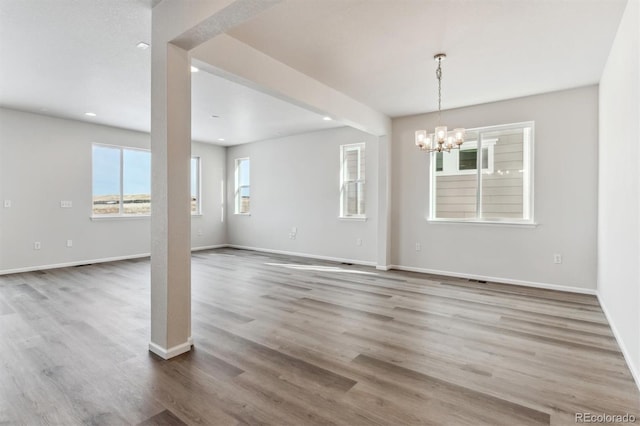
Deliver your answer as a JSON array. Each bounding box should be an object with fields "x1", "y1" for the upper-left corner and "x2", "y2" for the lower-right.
[{"x1": 429, "y1": 122, "x2": 534, "y2": 223}]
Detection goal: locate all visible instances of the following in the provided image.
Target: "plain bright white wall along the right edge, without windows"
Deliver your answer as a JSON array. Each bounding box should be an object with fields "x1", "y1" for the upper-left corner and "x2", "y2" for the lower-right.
[{"x1": 598, "y1": 1, "x2": 640, "y2": 386}]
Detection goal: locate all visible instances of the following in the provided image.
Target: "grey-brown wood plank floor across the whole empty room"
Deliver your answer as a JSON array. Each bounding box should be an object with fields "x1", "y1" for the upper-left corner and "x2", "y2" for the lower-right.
[{"x1": 0, "y1": 249, "x2": 640, "y2": 425}]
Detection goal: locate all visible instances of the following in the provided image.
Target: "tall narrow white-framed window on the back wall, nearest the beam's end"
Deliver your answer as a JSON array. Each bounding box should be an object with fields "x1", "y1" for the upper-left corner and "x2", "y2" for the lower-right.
[{"x1": 340, "y1": 143, "x2": 365, "y2": 218}]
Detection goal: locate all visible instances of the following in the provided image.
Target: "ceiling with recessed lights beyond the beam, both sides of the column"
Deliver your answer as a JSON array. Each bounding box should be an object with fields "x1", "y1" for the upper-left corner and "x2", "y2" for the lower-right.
[{"x1": 0, "y1": 0, "x2": 342, "y2": 145}]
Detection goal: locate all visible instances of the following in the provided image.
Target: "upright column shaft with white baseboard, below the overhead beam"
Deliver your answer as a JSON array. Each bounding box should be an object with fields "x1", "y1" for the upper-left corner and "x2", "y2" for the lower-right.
[{"x1": 149, "y1": 38, "x2": 192, "y2": 359}]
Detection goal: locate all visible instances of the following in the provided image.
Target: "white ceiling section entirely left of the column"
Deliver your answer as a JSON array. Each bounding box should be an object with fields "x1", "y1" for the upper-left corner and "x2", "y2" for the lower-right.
[{"x1": 0, "y1": 0, "x2": 151, "y2": 132}]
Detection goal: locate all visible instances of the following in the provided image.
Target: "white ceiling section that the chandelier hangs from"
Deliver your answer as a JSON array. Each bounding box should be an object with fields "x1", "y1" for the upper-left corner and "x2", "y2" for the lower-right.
[{"x1": 229, "y1": 0, "x2": 626, "y2": 117}]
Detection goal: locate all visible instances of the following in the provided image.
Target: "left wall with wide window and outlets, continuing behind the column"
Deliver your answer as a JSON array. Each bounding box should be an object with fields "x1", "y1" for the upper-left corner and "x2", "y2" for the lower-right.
[{"x1": 0, "y1": 108, "x2": 226, "y2": 273}]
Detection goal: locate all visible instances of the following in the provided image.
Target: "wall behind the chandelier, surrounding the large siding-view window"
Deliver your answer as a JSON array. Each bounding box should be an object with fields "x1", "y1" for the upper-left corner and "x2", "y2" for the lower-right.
[{"x1": 391, "y1": 86, "x2": 598, "y2": 292}]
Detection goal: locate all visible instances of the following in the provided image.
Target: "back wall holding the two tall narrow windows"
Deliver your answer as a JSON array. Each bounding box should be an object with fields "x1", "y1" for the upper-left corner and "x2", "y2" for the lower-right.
[{"x1": 227, "y1": 127, "x2": 378, "y2": 264}]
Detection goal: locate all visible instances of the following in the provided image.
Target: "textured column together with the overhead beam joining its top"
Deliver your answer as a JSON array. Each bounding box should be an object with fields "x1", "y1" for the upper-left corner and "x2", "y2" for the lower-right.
[{"x1": 149, "y1": 0, "x2": 280, "y2": 359}]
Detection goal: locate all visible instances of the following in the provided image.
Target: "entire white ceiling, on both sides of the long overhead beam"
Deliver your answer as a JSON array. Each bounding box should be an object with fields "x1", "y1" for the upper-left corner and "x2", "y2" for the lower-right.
[{"x1": 0, "y1": 0, "x2": 626, "y2": 145}]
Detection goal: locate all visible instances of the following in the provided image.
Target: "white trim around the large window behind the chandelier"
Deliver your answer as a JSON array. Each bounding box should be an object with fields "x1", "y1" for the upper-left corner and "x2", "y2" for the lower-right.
[{"x1": 426, "y1": 121, "x2": 538, "y2": 227}]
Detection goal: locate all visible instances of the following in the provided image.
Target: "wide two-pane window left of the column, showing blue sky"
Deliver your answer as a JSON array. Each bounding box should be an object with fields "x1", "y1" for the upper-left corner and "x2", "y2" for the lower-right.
[{"x1": 92, "y1": 144, "x2": 151, "y2": 216}]
